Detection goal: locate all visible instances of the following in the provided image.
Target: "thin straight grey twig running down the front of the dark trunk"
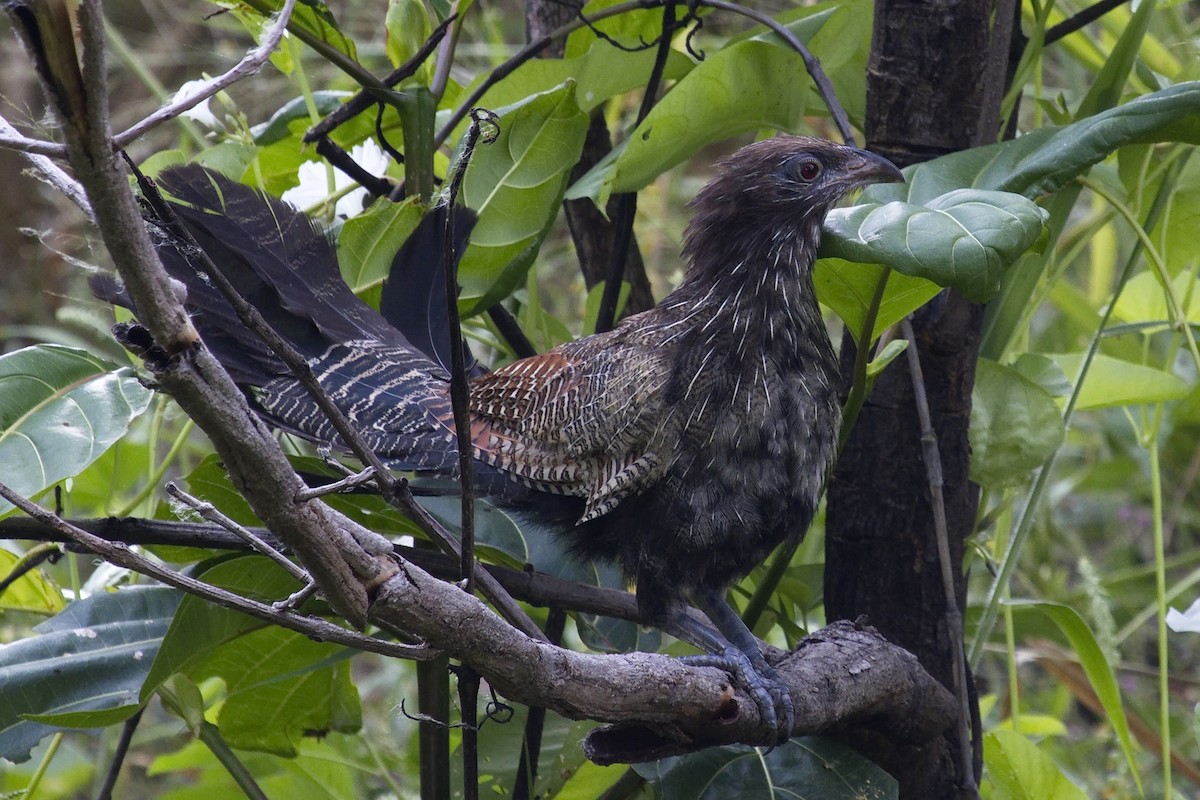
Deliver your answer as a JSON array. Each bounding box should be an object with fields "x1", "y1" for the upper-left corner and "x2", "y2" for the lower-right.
[{"x1": 900, "y1": 318, "x2": 976, "y2": 796}]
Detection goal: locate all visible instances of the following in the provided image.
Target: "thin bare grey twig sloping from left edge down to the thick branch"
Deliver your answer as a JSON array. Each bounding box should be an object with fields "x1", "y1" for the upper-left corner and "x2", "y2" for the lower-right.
[{"x1": 0, "y1": 483, "x2": 437, "y2": 661}]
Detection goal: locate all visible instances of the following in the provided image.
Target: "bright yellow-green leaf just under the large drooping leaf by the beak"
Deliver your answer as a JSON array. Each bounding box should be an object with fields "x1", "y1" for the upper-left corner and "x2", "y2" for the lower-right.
[{"x1": 812, "y1": 258, "x2": 942, "y2": 342}]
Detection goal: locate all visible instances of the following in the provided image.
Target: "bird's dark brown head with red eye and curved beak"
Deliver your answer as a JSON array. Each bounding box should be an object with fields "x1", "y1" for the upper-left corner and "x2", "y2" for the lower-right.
[{"x1": 684, "y1": 136, "x2": 904, "y2": 273}]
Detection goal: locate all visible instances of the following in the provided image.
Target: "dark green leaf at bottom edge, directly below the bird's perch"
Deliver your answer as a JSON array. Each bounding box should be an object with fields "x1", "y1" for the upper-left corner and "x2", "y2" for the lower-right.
[{"x1": 634, "y1": 736, "x2": 897, "y2": 800}]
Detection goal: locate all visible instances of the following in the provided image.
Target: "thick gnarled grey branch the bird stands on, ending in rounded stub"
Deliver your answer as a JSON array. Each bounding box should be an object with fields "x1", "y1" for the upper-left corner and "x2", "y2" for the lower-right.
[{"x1": 372, "y1": 564, "x2": 954, "y2": 763}]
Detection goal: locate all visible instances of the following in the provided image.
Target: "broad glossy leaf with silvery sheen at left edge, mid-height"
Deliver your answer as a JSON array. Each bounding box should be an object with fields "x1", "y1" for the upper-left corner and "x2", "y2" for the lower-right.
[{"x1": 0, "y1": 344, "x2": 151, "y2": 515}]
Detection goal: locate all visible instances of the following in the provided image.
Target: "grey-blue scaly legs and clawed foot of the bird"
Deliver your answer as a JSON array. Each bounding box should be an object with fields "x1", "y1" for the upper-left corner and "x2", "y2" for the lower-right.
[{"x1": 668, "y1": 589, "x2": 796, "y2": 742}]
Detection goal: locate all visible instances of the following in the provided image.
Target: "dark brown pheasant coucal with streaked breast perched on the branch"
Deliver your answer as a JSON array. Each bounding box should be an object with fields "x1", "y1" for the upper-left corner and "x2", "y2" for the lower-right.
[{"x1": 94, "y1": 137, "x2": 904, "y2": 738}]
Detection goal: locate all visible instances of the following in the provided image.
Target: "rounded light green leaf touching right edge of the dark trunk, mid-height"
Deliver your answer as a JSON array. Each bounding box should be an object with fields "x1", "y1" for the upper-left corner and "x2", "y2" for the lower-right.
[{"x1": 970, "y1": 359, "x2": 1066, "y2": 488}]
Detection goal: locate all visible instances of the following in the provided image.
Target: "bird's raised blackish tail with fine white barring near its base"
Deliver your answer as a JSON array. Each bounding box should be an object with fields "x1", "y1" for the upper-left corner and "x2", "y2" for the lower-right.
[{"x1": 91, "y1": 164, "x2": 474, "y2": 473}]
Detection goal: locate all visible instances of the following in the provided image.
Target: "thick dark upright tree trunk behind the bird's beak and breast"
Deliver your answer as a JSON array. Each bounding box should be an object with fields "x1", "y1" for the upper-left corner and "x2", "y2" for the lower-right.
[{"x1": 824, "y1": 0, "x2": 1019, "y2": 800}]
